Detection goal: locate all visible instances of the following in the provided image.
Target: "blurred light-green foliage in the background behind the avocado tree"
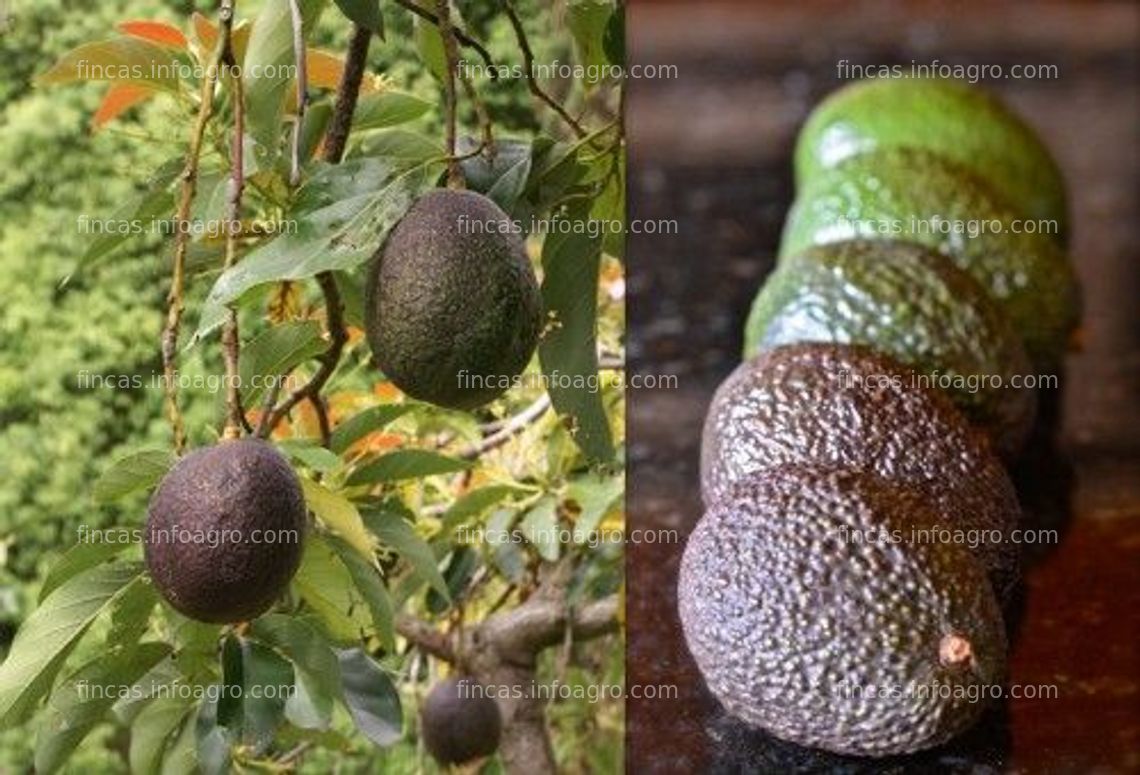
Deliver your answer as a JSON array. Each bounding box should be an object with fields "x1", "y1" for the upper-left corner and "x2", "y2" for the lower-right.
[{"x1": 0, "y1": 0, "x2": 622, "y2": 772}]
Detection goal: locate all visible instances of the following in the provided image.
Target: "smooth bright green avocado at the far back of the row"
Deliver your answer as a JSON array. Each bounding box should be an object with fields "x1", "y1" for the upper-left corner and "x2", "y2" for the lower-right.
[{"x1": 796, "y1": 79, "x2": 1068, "y2": 243}]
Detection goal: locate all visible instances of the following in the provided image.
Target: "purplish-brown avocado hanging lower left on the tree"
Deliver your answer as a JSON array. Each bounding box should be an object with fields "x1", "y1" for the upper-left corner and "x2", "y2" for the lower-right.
[{"x1": 143, "y1": 439, "x2": 307, "y2": 622}]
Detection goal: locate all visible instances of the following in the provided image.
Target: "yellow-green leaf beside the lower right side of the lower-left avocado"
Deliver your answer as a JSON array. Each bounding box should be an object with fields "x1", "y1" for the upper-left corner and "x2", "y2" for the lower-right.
[{"x1": 293, "y1": 533, "x2": 369, "y2": 643}]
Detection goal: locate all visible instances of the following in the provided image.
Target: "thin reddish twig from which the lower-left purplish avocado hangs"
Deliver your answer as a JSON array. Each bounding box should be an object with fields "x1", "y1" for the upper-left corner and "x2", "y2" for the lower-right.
[{"x1": 221, "y1": 16, "x2": 249, "y2": 439}]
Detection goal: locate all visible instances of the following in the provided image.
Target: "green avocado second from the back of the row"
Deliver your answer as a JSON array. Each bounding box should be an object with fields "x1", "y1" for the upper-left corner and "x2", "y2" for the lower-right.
[{"x1": 780, "y1": 148, "x2": 1080, "y2": 374}]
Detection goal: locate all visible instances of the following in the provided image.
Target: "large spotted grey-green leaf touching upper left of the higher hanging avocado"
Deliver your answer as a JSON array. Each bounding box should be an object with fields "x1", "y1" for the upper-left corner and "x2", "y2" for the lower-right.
[{"x1": 194, "y1": 160, "x2": 439, "y2": 342}]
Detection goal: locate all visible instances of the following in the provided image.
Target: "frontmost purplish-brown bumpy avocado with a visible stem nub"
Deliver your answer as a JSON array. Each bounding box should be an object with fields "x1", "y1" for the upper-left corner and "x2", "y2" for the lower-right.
[{"x1": 678, "y1": 466, "x2": 1005, "y2": 757}]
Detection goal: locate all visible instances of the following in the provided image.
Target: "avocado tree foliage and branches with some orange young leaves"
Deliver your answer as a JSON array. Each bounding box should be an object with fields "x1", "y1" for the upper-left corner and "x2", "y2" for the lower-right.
[{"x1": 0, "y1": 0, "x2": 625, "y2": 773}]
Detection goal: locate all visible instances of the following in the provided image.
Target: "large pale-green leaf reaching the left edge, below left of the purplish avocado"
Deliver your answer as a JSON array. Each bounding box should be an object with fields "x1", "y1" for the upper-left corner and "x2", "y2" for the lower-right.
[{"x1": 0, "y1": 563, "x2": 143, "y2": 728}]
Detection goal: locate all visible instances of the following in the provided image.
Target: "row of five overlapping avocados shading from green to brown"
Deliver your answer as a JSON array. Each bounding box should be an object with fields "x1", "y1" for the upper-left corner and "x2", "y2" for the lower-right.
[{"x1": 678, "y1": 80, "x2": 1080, "y2": 757}]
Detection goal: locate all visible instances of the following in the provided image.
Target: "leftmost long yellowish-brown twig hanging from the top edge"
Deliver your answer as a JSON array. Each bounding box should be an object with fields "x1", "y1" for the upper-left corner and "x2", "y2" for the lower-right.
[{"x1": 162, "y1": 0, "x2": 234, "y2": 452}]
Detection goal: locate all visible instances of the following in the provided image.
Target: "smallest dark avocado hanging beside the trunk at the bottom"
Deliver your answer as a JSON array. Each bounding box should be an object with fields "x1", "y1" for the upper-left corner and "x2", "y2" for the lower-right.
[{"x1": 420, "y1": 676, "x2": 503, "y2": 765}]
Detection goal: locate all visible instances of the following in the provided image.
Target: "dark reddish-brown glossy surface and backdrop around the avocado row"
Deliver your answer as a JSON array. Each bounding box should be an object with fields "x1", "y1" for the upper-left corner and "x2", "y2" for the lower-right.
[{"x1": 627, "y1": 0, "x2": 1140, "y2": 773}]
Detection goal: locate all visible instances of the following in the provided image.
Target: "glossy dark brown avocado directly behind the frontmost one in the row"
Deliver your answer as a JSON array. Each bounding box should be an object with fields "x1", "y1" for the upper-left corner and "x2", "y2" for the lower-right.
[{"x1": 701, "y1": 343, "x2": 1021, "y2": 601}]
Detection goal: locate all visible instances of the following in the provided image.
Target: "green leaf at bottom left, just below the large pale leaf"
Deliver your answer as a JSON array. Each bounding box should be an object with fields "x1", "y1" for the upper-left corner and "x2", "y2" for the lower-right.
[{"x1": 35, "y1": 643, "x2": 170, "y2": 773}]
